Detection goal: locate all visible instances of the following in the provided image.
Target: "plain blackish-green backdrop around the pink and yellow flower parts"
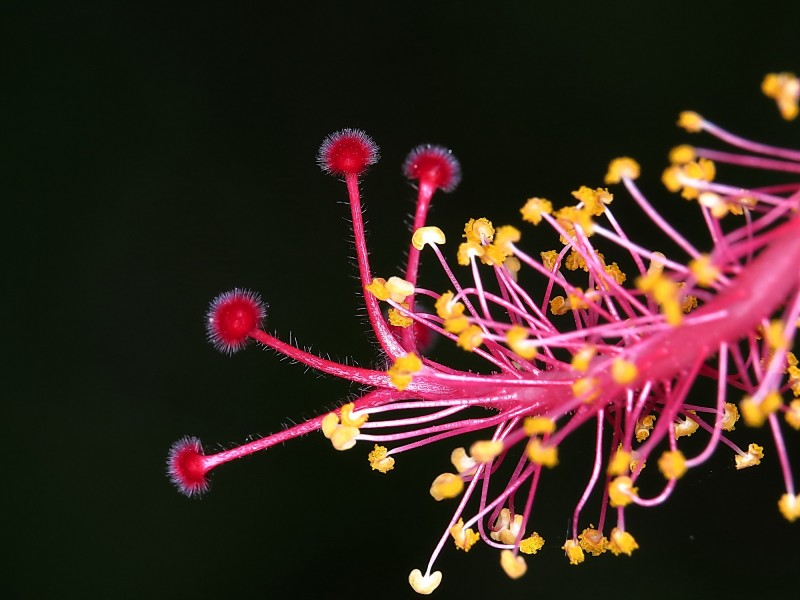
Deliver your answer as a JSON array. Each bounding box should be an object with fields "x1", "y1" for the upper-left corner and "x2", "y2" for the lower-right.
[{"x1": 6, "y1": 0, "x2": 800, "y2": 599}]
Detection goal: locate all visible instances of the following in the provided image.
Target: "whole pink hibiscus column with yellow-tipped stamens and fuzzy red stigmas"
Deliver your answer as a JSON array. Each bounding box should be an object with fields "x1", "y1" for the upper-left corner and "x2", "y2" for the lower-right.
[{"x1": 168, "y1": 74, "x2": 800, "y2": 594}]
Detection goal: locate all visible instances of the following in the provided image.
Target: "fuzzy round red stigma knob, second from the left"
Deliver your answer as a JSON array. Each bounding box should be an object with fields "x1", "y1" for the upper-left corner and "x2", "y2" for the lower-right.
[{"x1": 206, "y1": 288, "x2": 267, "y2": 354}]
